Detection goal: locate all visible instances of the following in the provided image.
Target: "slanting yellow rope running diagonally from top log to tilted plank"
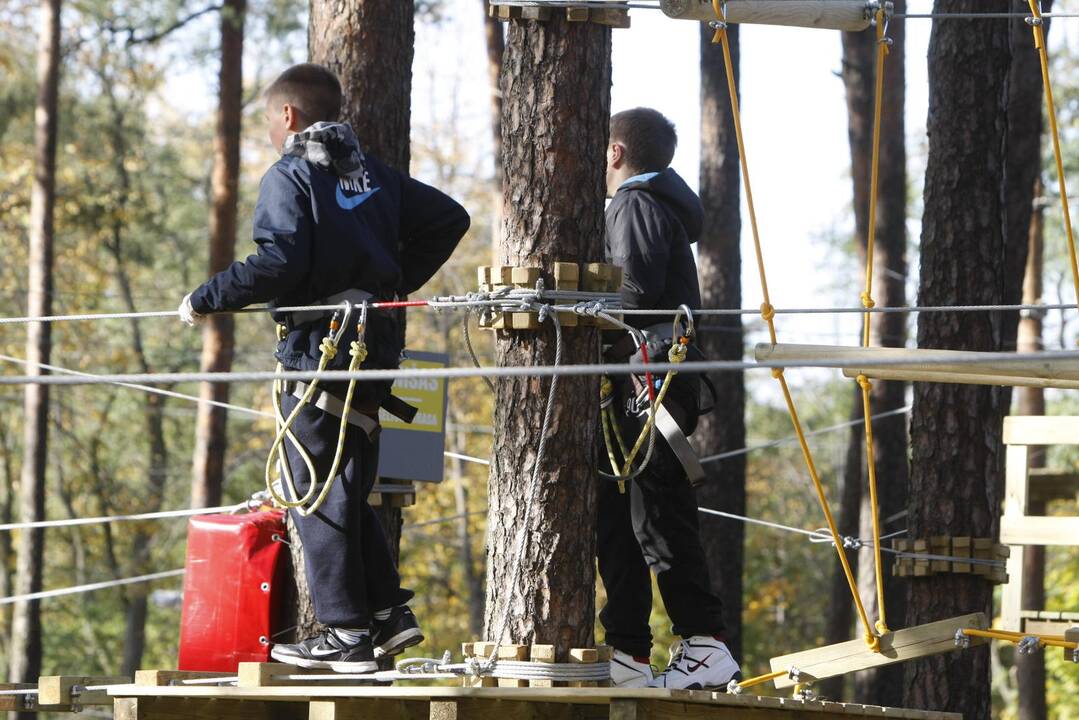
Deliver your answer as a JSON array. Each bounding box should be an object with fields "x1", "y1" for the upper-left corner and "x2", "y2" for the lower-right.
[{"x1": 712, "y1": 0, "x2": 880, "y2": 651}]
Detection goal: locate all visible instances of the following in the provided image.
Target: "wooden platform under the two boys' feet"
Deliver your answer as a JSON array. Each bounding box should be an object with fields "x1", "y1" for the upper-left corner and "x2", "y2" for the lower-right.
[{"x1": 103, "y1": 684, "x2": 962, "y2": 720}]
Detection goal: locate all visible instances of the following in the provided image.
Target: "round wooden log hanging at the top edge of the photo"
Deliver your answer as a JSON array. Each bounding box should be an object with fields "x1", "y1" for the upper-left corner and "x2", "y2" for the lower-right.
[{"x1": 659, "y1": 0, "x2": 870, "y2": 31}]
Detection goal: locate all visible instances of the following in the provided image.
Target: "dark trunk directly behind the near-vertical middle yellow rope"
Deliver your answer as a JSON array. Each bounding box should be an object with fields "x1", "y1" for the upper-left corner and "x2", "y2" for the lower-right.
[{"x1": 837, "y1": 0, "x2": 907, "y2": 707}]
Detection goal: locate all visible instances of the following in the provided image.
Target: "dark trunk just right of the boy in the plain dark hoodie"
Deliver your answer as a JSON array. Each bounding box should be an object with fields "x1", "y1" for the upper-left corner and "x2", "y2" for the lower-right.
[{"x1": 693, "y1": 25, "x2": 746, "y2": 658}]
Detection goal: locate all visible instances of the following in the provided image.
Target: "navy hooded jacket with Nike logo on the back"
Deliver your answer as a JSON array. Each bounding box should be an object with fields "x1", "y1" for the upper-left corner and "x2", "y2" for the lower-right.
[{"x1": 191, "y1": 123, "x2": 469, "y2": 370}]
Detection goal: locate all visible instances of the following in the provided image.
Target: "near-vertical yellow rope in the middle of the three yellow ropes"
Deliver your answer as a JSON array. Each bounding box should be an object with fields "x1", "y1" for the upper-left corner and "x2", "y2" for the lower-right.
[{"x1": 856, "y1": 6, "x2": 891, "y2": 635}]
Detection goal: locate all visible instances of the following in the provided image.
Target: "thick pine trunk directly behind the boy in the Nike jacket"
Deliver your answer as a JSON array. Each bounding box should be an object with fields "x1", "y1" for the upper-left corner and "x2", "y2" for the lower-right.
[{"x1": 288, "y1": 0, "x2": 415, "y2": 637}]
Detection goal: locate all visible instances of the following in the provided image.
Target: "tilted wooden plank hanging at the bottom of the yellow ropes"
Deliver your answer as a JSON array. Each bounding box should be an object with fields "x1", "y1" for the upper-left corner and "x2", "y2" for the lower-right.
[{"x1": 770, "y1": 612, "x2": 988, "y2": 689}]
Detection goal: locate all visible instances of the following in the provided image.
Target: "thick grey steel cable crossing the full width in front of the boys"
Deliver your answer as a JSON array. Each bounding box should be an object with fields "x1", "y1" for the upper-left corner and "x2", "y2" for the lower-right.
[{"x1": 0, "y1": 348, "x2": 1079, "y2": 385}]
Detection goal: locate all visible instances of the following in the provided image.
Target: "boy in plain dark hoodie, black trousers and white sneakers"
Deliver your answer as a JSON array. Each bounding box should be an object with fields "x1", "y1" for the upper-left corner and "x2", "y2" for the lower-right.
[{"x1": 597, "y1": 108, "x2": 741, "y2": 689}]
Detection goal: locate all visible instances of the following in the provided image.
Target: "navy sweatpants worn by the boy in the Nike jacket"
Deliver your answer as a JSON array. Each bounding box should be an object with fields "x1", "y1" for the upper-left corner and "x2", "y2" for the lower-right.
[{"x1": 282, "y1": 392, "x2": 413, "y2": 628}]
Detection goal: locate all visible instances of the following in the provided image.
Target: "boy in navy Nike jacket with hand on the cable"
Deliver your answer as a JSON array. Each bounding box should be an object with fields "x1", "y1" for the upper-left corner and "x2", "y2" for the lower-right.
[{"x1": 179, "y1": 64, "x2": 469, "y2": 673}]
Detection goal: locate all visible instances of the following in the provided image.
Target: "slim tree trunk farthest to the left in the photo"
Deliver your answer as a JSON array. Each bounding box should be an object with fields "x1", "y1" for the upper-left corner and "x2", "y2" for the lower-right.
[{"x1": 9, "y1": 0, "x2": 60, "y2": 690}]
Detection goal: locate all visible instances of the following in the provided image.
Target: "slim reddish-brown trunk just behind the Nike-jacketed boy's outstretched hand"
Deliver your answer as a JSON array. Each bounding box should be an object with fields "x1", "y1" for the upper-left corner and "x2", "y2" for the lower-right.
[{"x1": 191, "y1": 0, "x2": 247, "y2": 507}]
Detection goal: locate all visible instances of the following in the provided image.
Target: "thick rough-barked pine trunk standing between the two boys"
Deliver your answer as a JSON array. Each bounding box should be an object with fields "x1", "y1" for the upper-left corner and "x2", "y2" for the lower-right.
[{"x1": 484, "y1": 12, "x2": 611, "y2": 658}]
